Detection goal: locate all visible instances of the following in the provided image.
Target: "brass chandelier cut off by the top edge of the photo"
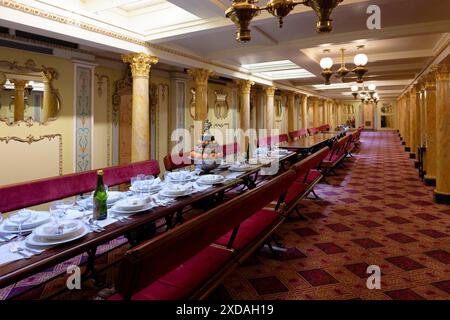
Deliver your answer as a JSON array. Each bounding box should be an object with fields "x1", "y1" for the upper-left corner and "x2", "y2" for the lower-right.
[{"x1": 225, "y1": 0, "x2": 343, "y2": 42}]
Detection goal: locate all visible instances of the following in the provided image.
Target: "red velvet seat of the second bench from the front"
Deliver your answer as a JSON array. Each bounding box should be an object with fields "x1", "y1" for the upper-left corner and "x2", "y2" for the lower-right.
[{"x1": 215, "y1": 209, "x2": 279, "y2": 250}]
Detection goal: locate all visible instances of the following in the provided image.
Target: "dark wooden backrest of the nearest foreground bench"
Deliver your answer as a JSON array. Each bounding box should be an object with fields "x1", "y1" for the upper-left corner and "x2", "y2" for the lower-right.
[{"x1": 116, "y1": 170, "x2": 295, "y2": 299}]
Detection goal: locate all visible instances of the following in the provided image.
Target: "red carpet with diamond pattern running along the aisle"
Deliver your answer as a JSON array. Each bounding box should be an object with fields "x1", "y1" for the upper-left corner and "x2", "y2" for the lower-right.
[{"x1": 213, "y1": 132, "x2": 450, "y2": 300}]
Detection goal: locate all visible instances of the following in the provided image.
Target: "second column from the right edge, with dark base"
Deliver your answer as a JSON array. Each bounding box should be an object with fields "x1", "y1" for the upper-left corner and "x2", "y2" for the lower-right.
[{"x1": 424, "y1": 74, "x2": 437, "y2": 186}]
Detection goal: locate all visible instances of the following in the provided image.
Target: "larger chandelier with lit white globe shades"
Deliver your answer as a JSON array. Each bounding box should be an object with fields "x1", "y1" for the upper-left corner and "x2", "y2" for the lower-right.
[{"x1": 320, "y1": 46, "x2": 369, "y2": 85}]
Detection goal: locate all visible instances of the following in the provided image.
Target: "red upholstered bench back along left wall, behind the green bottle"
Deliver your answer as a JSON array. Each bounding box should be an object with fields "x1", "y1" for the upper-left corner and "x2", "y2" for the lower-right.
[{"x1": 0, "y1": 160, "x2": 160, "y2": 213}]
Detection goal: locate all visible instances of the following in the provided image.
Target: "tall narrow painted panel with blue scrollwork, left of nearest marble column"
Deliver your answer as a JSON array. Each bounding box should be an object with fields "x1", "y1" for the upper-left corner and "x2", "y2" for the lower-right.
[{"x1": 75, "y1": 65, "x2": 92, "y2": 172}]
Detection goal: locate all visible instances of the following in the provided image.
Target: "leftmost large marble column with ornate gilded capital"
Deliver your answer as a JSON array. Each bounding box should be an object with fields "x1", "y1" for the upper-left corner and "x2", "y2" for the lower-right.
[{"x1": 122, "y1": 53, "x2": 158, "y2": 162}]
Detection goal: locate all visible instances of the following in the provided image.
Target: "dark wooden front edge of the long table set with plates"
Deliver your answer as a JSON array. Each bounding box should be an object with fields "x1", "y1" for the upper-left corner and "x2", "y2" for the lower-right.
[{"x1": 0, "y1": 152, "x2": 296, "y2": 289}]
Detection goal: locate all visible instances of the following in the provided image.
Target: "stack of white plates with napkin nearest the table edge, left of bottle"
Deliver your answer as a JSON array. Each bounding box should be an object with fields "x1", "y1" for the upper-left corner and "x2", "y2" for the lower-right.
[{"x1": 26, "y1": 220, "x2": 89, "y2": 247}]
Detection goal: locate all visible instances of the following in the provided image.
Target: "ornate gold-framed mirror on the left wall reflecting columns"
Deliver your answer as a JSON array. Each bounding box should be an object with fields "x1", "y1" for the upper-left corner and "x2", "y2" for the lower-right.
[{"x1": 0, "y1": 59, "x2": 61, "y2": 126}]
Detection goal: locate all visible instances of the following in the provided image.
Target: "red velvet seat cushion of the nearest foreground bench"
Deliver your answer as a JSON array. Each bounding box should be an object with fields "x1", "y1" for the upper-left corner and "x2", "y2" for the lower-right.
[{"x1": 109, "y1": 246, "x2": 232, "y2": 300}]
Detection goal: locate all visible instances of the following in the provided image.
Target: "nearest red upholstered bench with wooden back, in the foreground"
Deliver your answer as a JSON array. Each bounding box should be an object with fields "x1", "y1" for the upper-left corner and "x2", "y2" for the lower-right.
[{"x1": 111, "y1": 171, "x2": 295, "y2": 300}]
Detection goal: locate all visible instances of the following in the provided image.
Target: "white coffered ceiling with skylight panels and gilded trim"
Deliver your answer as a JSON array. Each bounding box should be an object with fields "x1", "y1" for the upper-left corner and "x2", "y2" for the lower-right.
[{"x1": 0, "y1": 0, "x2": 450, "y2": 99}]
